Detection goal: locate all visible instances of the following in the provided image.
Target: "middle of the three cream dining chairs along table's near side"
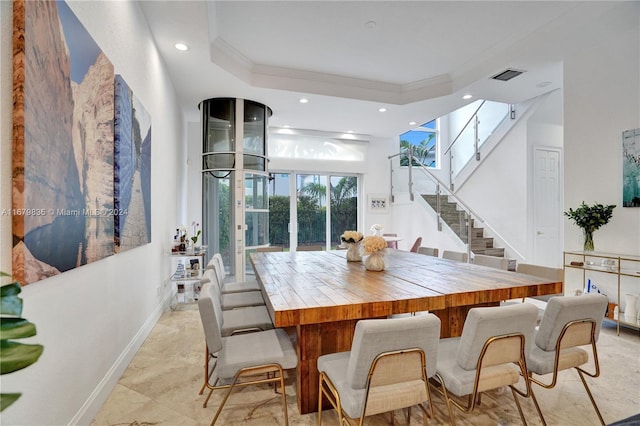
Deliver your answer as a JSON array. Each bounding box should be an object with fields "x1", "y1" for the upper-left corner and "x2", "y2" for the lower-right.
[{"x1": 436, "y1": 303, "x2": 538, "y2": 425}]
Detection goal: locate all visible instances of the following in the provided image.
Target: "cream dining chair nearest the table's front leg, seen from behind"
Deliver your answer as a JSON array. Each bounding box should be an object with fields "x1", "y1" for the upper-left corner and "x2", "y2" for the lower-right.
[{"x1": 318, "y1": 314, "x2": 440, "y2": 426}]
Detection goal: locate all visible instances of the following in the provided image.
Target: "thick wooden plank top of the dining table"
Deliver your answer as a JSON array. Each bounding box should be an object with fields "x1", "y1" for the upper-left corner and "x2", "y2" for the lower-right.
[{"x1": 250, "y1": 249, "x2": 562, "y2": 327}]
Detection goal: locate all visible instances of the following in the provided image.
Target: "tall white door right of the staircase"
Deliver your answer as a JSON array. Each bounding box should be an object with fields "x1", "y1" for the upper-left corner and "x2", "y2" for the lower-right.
[{"x1": 533, "y1": 147, "x2": 562, "y2": 267}]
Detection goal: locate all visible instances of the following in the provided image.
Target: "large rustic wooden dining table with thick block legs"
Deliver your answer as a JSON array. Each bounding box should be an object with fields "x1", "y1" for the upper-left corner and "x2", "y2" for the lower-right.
[{"x1": 250, "y1": 249, "x2": 563, "y2": 414}]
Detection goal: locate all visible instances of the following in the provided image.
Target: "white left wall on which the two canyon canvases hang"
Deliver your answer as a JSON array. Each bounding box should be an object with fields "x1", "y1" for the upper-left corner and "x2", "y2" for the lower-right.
[{"x1": 0, "y1": 1, "x2": 184, "y2": 425}]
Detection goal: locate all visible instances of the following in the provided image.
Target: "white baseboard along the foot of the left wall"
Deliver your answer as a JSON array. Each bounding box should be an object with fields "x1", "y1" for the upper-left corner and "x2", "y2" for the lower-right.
[{"x1": 69, "y1": 292, "x2": 172, "y2": 426}]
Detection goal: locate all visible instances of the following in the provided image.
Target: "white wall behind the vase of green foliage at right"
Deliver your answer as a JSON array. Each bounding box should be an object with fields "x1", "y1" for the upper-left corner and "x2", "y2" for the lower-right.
[{"x1": 564, "y1": 2, "x2": 640, "y2": 255}]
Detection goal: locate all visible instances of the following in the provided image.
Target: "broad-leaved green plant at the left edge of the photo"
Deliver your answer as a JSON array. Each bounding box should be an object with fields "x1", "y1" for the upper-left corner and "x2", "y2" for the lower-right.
[{"x1": 0, "y1": 272, "x2": 44, "y2": 411}]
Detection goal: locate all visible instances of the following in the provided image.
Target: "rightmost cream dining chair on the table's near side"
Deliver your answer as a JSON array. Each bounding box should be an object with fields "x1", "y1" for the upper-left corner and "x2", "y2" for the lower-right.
[{"x1": 527, "y1": 294, "x2": 609, "y2": 425}]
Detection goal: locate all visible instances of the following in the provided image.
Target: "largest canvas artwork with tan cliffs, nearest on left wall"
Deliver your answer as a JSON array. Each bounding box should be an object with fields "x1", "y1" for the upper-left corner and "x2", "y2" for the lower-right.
[{"x1": 12, "y1": 0, "x2": 114, "y2": 285}]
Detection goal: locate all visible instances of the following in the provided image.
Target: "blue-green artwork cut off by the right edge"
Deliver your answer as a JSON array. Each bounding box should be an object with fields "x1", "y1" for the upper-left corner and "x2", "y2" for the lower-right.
[{"x1": 622, "y1": 129, "x2": 640, "y2": 207}]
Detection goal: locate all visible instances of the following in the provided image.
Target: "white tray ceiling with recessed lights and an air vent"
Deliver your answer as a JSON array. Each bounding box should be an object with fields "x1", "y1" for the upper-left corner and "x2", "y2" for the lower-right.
[{"x1": 140, "y1": 0, "x2": 612, "y2": 137}]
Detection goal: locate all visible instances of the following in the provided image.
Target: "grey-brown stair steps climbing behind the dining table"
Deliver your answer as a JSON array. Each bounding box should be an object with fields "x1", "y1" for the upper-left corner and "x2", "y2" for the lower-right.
[{"x1": 422, "y1": 194, "x2": 504, "y2": 257}]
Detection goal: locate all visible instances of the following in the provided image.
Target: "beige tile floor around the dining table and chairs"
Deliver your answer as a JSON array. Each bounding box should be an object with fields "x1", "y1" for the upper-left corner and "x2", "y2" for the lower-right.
[{"x1": 91, "y1": 305, "x2": 640, "y2": 426}]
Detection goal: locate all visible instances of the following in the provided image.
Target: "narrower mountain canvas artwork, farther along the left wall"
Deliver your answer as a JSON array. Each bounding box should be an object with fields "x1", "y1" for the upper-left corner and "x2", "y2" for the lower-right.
[{"x1": 114, "y1": 75, "x2": 151, "y2": 252}]
